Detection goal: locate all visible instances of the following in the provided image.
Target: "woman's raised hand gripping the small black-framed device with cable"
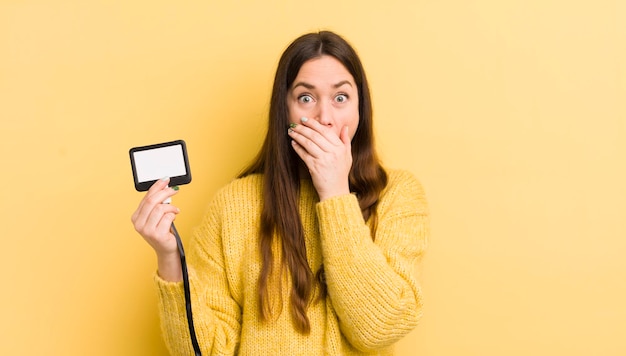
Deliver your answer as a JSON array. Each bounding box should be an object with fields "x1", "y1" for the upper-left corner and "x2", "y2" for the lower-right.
[{"x1": 131, "y1": 179, "x2": 182, "y2": 282}]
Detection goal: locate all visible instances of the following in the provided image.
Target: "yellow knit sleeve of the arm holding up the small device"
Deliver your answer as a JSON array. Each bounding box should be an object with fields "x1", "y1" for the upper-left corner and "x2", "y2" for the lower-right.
[{"x1": 155, "y1": 193, "x2": 241, "y2": 355}]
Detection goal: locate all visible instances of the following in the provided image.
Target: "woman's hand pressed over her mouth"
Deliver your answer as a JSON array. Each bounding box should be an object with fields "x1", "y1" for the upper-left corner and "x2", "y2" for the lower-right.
[{"x1": 289, "y1": 118, "x2": 352, "y2": 201}]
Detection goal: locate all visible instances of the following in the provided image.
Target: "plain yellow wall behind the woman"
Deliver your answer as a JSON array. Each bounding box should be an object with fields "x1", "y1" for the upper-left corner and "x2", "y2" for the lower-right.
[{"x1": 0, "y1": 0, "x2": 626, "y2": 356}]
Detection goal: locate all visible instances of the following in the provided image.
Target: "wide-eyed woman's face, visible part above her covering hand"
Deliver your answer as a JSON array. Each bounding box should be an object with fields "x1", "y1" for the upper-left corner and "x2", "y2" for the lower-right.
[{"x1": 287, "y1": 55, "x2": 359, "y2": 138}]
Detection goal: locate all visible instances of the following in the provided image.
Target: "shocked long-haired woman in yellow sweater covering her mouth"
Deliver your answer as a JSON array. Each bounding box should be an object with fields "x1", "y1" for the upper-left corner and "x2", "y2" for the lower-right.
[{"x1": 132, "y1": 31, "x2": 428, "y2": 355}]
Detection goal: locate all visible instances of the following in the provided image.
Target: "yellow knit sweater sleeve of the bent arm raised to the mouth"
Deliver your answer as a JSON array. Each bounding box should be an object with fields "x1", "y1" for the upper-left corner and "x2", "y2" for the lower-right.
[{"x1": 317, "y1": 172, "x2": 428, "y2": 351}]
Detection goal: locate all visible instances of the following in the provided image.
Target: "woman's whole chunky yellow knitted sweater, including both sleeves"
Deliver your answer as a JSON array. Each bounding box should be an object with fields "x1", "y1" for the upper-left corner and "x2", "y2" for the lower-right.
[{"x1": 155, "y1": 171, "x2": 428, "y2": 356}]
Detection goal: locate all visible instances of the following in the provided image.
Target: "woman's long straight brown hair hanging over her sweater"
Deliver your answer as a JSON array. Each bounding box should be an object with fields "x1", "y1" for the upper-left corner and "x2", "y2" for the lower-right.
[{"x1": 240, "y1": 31, "x2": 387, "y2": 334}]
